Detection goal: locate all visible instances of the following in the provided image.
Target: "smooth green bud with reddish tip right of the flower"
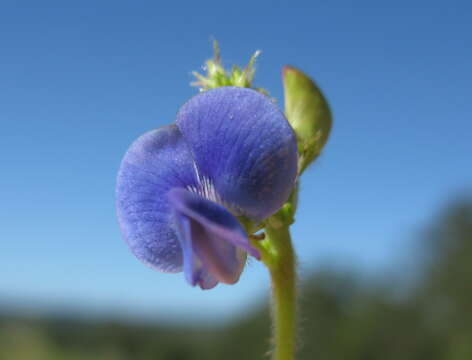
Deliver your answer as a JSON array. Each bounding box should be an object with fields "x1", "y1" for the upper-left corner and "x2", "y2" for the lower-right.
[{"x1": 282, "y1": 66, "x2": 332, "y2": 174}]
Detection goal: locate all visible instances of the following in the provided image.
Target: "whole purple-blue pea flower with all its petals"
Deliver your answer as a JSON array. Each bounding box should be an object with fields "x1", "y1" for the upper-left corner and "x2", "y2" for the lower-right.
[{"x1": 117, "y1": 87, "x2": 297, "y2": 289}]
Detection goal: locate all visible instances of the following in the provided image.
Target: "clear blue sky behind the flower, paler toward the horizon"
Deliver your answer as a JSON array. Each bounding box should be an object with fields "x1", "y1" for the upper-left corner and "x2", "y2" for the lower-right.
[{"x1": 0, "y1": 0, "x2": 472, "y2": 320}]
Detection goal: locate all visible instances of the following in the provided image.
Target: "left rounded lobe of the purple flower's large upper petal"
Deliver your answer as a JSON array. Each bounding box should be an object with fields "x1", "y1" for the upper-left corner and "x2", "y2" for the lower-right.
[{"x1": 116, "y1": 125, "x2": 196, "y2": 272}]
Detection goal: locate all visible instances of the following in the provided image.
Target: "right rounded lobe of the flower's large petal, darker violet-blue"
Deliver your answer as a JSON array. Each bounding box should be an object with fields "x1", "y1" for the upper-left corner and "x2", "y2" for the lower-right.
[{"x1": 176, "y1": 87, "x2": 298, "y2": 220}]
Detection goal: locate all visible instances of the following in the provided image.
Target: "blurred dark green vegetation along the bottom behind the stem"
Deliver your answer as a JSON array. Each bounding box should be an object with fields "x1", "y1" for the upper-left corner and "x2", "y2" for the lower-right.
[{"x1": 0, "y1": 201, "x2": 472, "y2": 360}]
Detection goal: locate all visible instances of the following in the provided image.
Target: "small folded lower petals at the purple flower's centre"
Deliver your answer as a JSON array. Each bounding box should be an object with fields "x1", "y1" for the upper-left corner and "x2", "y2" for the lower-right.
[{"x1": 168, "y1": 189, "x2": 260, "y2": 288}]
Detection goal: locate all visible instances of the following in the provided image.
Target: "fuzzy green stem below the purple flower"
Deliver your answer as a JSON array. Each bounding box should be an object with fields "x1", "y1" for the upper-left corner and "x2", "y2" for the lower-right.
[{"x1": 262, "y1": 225, "x2": 296, "y2": 360}]
